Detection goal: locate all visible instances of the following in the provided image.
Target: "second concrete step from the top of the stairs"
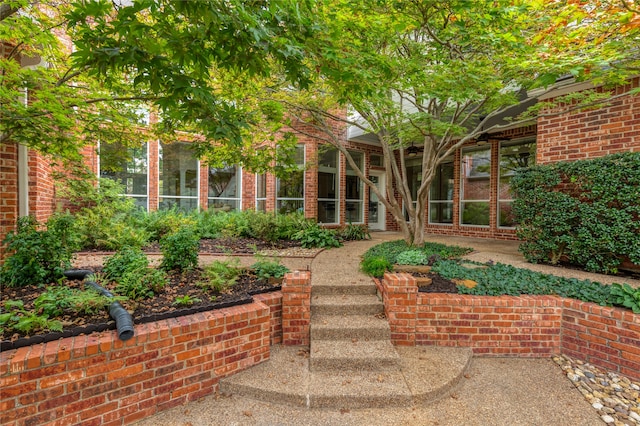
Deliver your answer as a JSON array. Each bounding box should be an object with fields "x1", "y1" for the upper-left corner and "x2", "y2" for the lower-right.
[{"x1": 311, "y1": 295, "x2": 384, "y2": 315}]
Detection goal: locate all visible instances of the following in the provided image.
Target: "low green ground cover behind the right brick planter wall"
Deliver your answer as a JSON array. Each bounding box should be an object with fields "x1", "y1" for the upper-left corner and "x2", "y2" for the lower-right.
[{"x1": 362, "y1": 241, "x2": 640, "y2": 313}]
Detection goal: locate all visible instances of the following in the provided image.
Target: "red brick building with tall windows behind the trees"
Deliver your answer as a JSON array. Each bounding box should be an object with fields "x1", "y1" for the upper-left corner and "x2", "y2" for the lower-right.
[{"x1": 0, "y1": 79, "x2": 640, "y2": 250}]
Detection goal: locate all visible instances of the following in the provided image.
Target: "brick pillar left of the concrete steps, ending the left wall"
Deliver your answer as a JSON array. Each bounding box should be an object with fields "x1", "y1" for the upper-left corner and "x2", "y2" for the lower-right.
[{"x1": 282, "y1": 271, "x2": 311, "y2": 346}]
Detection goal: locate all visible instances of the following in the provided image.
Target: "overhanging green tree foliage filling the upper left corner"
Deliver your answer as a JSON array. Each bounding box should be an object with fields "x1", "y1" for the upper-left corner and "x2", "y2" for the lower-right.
[{"x1": 0, "y1": 0, "x2": 314, "y2": 171}]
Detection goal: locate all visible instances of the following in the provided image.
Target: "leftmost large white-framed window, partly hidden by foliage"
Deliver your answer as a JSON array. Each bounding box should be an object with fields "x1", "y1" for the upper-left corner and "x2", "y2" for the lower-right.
[{"x1": 100, "y1": 144, "x2": 149, "y2": 210}]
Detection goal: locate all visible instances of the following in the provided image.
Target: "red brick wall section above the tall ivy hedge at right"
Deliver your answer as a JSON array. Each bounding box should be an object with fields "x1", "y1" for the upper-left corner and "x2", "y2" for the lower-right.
[{"x1": 537, "y1": 78, "x2": 640, "y2": 164}]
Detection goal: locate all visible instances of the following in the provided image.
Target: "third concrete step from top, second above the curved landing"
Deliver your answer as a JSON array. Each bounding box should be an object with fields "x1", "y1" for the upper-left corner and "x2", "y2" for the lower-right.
[{"x1": 311, "y1": 315, "x2": 391, "y2": 341}]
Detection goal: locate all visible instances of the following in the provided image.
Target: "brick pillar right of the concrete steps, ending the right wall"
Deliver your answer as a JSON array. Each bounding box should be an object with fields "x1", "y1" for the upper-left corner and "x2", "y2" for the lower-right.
[{"x1": 382, "y1": 273, "x2": 418, "y2": 346}]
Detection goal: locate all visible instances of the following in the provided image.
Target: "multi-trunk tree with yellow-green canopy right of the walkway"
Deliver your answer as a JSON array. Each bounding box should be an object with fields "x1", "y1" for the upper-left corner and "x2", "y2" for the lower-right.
[{"x1": 284, "y1": 0, "x2": 636, "y2": 245}]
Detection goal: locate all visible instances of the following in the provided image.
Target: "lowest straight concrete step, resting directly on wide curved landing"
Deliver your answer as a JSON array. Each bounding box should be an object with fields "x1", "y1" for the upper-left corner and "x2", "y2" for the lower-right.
[{"x1": 309, "y1": 339, "x2": 400, "y2": 372}]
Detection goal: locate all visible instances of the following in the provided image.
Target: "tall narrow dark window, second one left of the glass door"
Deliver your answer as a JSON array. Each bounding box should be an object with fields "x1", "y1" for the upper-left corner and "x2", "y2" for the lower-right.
[{"x1": 318, "y1": 148, "x2": 340, "y2": 223}]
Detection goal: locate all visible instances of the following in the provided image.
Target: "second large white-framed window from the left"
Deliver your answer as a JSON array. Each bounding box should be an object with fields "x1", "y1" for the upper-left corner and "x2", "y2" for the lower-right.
[{"x1": 158, "y1": 142, "x2": 198, "y2": 211}]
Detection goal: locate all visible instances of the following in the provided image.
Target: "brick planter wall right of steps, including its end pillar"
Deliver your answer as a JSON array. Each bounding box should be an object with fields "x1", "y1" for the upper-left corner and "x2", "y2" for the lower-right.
[{"x1": 378, "y1": 274, "x2": 640, "y2": 379}]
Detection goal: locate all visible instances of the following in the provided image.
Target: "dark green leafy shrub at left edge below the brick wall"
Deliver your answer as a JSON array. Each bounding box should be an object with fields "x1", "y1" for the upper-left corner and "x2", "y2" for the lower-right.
[{"x1": 0, "y1": 215, "x2": 75, "y2": 287}]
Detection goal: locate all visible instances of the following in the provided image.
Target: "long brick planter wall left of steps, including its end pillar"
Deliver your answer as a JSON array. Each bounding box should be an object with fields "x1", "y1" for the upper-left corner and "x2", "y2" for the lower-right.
[{"x1": 0, "y1": 272, "x2": 310, "y2": 425}]
